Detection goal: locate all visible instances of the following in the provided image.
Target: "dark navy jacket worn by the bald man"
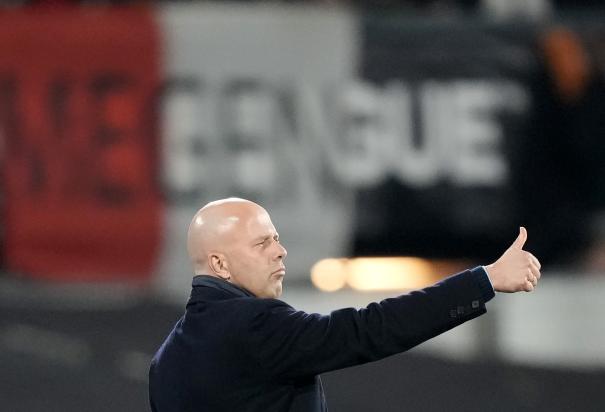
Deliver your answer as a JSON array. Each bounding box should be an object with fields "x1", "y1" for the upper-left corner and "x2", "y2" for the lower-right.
[{"x1": 149, "y1": 267, "x2": 494, "y2": 412}]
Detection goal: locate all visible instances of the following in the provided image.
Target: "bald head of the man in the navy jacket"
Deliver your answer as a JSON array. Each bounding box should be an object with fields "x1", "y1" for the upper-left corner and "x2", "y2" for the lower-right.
[{"x1": 187, "y1": 198, "x2": 286, "y2": 296}]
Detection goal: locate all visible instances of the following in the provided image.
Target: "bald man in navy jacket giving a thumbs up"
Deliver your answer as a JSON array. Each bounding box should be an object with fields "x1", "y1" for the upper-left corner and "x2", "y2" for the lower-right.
[{"x1": 149, "y1": 198, "x2": 540, "y2": 412}]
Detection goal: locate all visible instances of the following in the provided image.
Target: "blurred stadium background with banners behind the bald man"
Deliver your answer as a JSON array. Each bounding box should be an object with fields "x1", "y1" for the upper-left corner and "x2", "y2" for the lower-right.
[{"x1": 0, "y1": 0, "x2": 605, "y2": 412}]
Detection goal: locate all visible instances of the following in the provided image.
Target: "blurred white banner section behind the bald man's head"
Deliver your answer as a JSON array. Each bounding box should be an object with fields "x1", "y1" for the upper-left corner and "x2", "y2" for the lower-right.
[{"x1": 157, "y1": 5, "x2": 358, "y2": 296}]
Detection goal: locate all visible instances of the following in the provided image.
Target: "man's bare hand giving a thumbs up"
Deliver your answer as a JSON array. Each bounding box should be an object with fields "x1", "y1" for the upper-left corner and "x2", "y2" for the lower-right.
[{"x1": 485, "y1": 227, "x2": 541, "y2": 293}]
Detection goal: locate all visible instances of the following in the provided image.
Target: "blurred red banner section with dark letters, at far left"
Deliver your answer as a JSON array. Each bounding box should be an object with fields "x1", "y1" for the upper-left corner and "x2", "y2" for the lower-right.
[{"x1": 0, "y1": 8, "x2": 161, "y2": 280}]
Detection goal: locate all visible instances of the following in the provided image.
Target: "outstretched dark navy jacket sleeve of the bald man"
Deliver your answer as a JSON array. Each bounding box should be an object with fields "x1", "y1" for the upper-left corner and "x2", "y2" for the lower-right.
[{"x1": 246, "y1": 267, "x2": 495, "y2": 379}]
